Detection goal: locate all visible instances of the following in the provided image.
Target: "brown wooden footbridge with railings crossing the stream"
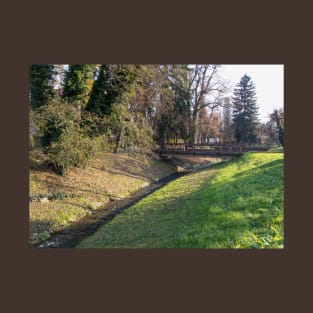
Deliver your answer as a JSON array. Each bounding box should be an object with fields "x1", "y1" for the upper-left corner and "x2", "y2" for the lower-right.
[{"x1": 154, "y1": 143, "x2": 271, "y2": 156}]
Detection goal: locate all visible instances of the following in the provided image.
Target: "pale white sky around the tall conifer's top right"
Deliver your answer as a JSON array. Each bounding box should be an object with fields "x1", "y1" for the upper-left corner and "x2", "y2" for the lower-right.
[{"x1": 220, "y1": 64, "x2": 284, "y2": 122}]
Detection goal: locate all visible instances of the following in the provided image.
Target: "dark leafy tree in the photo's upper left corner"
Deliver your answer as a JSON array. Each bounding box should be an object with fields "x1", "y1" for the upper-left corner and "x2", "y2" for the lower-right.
[{"x1": 29, "y1": 64, "x2": 54, "y2": 109}]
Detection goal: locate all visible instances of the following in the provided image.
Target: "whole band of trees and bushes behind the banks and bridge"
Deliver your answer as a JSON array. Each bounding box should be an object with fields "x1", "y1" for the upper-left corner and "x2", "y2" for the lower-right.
[{"x1": 29, "y1": 64, "x2": 277, "y2": 174}]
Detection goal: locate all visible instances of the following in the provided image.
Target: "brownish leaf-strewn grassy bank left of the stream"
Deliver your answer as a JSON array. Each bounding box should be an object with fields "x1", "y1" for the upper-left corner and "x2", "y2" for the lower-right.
[{"x1": 29, "y1": 153, "x2": 176, "y2": 244}]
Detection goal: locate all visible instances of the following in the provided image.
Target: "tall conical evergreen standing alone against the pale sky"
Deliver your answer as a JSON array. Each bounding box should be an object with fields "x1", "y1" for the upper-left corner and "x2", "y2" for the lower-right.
[{"x1": 232, "y1": 75, "x2": 258, "y2": 143}]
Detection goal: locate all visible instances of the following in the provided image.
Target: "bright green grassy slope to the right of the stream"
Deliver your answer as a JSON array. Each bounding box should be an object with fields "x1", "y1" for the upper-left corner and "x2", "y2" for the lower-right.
[{"x1": 78, "y1": 152, "x2": 284, "y2": 248}]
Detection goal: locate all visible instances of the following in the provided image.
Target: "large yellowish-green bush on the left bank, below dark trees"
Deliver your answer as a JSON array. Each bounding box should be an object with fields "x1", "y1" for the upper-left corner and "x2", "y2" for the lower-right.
[{"x1": 29, "y1": 99, "x2": 114, "y2": 175}]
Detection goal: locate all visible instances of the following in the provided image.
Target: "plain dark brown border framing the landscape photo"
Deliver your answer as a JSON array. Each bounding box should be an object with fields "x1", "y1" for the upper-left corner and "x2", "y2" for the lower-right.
[{"x1": 1, "y1": 1, "x2": 313, "y2": 312}]
